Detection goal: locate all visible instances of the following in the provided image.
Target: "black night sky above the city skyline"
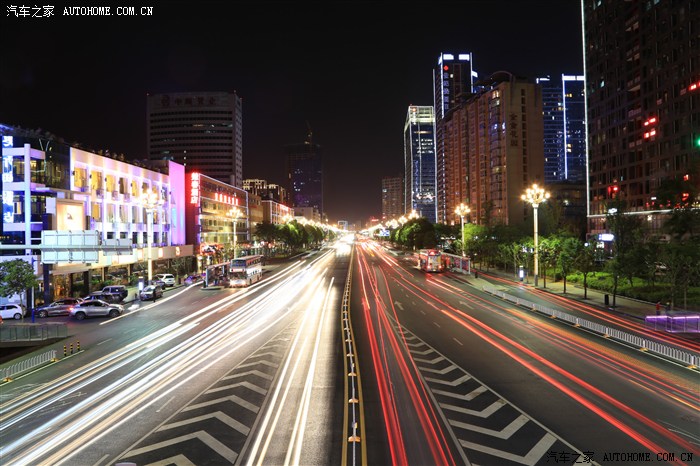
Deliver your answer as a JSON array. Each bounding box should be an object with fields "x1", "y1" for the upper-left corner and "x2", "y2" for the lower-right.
[{"x1": 0, "y1": 0, "x2": 583, "y2": 226}]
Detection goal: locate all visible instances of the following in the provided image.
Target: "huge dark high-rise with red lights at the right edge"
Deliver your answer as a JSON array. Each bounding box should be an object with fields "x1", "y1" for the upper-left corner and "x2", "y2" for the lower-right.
[{"x1": 582, "y1": 0, "x2": 700, "y2": 233}]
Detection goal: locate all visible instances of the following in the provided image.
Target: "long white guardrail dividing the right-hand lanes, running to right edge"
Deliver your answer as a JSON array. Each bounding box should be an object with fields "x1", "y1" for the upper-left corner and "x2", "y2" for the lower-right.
[{"x1": 482, "y1": 286, "x2": 700, "y2": 368}]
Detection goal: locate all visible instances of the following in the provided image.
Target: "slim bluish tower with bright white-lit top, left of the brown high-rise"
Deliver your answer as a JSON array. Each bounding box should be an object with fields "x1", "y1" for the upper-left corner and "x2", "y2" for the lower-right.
[{"x1": 403, "y1": 105, "x2": 436, "y2": 223}]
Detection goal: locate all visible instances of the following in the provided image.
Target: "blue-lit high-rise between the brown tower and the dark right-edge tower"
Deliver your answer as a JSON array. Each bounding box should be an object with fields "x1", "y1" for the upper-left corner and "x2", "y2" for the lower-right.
[{"x1": 537, "y1": 74, "x2": 586, "y2": 184}]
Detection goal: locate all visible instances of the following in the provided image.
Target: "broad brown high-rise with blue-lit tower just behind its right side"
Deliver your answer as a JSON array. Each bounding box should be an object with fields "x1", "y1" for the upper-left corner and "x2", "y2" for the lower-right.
[{"x1": 464, "y1": 71, "x2": 544, "y2": 225}]
